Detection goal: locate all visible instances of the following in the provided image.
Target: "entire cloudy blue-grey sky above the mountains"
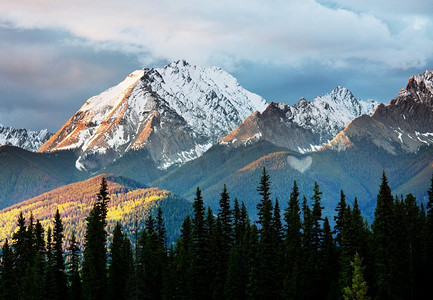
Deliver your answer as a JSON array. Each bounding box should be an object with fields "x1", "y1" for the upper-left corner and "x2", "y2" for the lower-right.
[{"x1": 0, "y1": 0, "x2": 433, "y2": 131}]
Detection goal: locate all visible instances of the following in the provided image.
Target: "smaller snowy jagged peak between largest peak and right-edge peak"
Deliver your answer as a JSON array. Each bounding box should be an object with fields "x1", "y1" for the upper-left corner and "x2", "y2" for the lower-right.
[{"x1": 220, "y1": 87, "x2": 378, "y2": 152}]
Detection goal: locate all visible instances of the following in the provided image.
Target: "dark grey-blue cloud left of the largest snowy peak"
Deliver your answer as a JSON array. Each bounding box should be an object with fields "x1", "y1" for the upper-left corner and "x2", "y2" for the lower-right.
[{"x1": 0, "y1": 28, "x2": 139, "y2": 131}]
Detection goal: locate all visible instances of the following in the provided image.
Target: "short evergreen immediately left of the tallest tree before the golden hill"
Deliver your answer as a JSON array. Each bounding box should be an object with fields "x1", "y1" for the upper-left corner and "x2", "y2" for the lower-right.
[{"x1": 67, "y1": 232, "x2": 81, "y2": 300}]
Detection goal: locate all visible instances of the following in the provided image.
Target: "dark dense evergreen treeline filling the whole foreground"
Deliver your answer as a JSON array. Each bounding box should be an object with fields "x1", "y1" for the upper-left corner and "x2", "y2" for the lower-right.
[{"x1": 0, "y1": 169, "x2": 433, "y2": 299}]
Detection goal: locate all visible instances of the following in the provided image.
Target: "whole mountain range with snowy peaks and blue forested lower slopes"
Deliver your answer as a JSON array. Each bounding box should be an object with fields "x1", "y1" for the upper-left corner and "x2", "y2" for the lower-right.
[{"x1": 0, "y1": 60, "x2": 433, "y2": 234}]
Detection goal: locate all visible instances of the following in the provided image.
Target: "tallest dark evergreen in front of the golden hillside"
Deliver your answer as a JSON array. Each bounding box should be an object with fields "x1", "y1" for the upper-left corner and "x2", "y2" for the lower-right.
[{"x1": 83, "y1": 178, "x2": 110, "y2": 299}]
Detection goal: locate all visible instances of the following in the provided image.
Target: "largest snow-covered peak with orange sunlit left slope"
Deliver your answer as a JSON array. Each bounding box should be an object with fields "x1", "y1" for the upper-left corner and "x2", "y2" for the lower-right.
[{"x1": 39, "y1": 61, "x2": 266, "y2": 171}]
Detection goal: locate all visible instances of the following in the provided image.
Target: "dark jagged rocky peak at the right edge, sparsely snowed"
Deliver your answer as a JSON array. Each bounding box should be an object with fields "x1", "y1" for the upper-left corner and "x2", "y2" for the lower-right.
[{"x1": 326, "y1": 71, "x2": 433, "y2": 154}]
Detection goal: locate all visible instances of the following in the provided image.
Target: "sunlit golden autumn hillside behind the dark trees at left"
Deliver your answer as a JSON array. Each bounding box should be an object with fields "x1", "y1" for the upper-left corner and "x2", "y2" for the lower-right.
[{"x1": 0, "y1": 175, "x2": 191, "y2": 246}]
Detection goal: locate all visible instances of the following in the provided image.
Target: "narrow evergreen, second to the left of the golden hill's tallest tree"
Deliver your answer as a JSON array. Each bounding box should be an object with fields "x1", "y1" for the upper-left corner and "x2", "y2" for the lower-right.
[{"x1": 52, "y1": 209, "x2": 66, "y2": 300}]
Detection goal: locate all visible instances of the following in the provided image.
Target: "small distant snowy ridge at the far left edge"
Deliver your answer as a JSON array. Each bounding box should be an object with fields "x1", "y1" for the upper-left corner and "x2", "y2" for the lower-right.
[{"x1": 0, "y1": 125, "x2": 52, "y2": 151}]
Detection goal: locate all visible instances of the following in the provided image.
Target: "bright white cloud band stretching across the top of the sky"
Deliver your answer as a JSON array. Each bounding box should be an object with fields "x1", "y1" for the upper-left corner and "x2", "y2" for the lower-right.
[{"x1": 0, "y1": 0, "x2": 433, "y2": 69}]
